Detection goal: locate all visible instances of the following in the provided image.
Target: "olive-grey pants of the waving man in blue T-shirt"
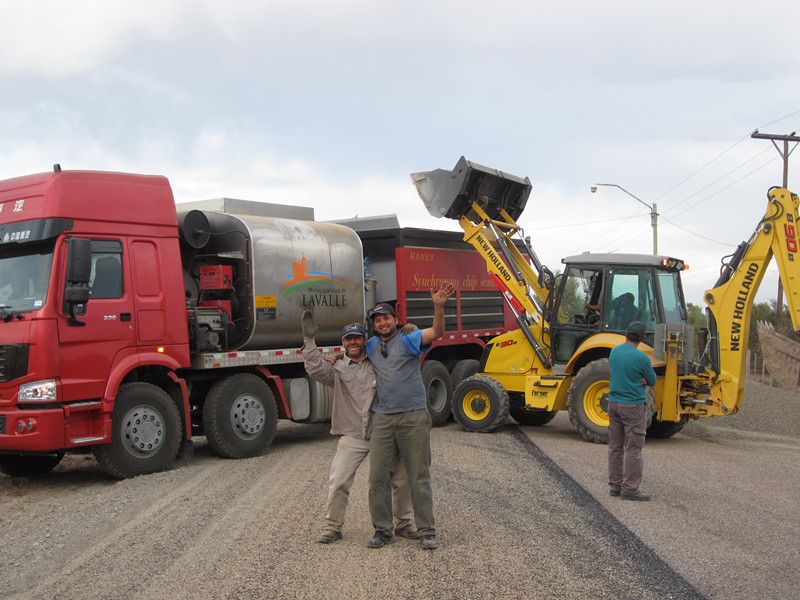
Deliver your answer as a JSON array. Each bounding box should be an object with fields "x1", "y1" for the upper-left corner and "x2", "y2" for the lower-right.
[{"x1": 369, "y1": 408, "x2": 436, "y2": 535}]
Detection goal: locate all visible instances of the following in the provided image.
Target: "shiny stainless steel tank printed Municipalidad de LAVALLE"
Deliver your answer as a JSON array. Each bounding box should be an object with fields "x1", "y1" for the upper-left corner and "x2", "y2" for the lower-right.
[{"x1": 203, "y1": 213, "x2": 364, "y2": 350}]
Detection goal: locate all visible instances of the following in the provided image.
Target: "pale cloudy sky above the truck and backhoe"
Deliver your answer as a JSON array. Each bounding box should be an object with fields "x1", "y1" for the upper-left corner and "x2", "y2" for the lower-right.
[{"x1": 0, "y1": 0, "x2": 800, "y2": 304}]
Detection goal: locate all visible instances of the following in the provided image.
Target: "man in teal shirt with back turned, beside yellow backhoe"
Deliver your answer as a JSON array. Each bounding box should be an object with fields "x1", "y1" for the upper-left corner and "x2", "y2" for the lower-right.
[{"x1": 608, "y1": 321, "x2": 656, "y2": 501}]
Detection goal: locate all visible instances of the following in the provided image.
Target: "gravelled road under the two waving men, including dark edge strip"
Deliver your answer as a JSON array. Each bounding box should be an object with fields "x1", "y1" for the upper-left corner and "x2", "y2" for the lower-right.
[{"x1": 0, "y1": 425, "x2": 699, "y2": 598}]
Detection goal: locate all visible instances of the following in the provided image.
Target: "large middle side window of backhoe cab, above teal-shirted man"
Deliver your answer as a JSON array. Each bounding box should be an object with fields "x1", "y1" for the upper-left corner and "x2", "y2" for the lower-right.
[{"x1": 603, "y1": 267, "x2": 658, "y2": 332}]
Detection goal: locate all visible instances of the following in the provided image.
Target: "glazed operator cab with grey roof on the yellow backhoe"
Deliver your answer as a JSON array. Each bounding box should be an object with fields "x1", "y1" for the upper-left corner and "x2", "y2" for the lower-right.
[{"x1": 550, "y1": 254, "x2": 687, "y2": 364}]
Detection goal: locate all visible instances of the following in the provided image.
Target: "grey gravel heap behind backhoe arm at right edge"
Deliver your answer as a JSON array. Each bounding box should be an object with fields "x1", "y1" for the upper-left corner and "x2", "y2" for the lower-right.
[{"x1": 695, "y1": 381, "x2": 800, "y2": 437}]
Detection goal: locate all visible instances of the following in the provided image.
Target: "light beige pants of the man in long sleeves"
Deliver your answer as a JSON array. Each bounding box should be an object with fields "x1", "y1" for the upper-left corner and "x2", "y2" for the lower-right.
[{"x1": 325, "y1": 435, "x2": 414, "y2": 531}]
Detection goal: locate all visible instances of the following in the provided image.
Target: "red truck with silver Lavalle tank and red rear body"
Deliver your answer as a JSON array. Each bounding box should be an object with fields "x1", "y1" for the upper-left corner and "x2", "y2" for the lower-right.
[{"x1": 0, "y1": 167, "x2": 514, "y2": 478}]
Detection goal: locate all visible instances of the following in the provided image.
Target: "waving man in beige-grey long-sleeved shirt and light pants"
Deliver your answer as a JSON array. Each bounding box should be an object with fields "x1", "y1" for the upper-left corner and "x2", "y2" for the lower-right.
[{"x1": 301, "y1": 310, "x2": 417, "y2": 544}]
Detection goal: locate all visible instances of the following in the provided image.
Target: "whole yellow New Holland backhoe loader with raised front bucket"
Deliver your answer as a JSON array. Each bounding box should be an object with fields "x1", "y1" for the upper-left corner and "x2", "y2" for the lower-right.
[{"x1": 411, "y1": 157, "x2": 800, "y2": 443}]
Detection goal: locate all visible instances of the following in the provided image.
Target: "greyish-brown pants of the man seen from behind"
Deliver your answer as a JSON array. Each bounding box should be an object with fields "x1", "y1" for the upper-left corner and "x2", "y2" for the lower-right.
[{"x1": 608, "y1": 402, "x2": 647, "y2": 494}]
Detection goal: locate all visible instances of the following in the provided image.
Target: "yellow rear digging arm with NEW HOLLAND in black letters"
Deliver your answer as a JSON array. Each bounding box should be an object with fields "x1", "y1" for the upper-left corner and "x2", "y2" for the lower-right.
[{"x1": 704, "y1": 188, "x2": 800, "y2": 414}]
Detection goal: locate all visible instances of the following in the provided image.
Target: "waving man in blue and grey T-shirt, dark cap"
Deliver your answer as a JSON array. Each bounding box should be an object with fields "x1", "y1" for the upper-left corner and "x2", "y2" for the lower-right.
[{"x1": 367, "y1": 283, "x2": 453, "y2": 550}]
